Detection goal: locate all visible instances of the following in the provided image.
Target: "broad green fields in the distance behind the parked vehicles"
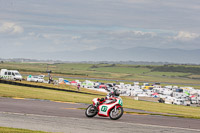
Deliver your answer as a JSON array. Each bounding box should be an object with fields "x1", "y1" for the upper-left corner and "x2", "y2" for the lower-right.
[{"x1": 0, "y1": 63, "x2": 200, "y2": 88}]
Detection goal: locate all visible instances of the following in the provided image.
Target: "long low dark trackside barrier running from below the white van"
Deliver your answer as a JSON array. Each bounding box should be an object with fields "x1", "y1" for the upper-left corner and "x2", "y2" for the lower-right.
[{"x1": 0, "y1": 79, "x2": 104, "y2": 96}]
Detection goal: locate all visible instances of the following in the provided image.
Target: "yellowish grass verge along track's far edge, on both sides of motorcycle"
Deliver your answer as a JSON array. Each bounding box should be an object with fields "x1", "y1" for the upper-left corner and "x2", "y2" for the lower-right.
[{"x1": 0, "y1": 83, "x2": 200, "y2": 119}]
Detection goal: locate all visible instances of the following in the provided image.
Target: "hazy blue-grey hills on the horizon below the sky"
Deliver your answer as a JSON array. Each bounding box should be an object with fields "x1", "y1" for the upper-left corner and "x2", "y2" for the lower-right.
[{"x1": 4, "y1": 47, "x2": 200, "y2": 64}]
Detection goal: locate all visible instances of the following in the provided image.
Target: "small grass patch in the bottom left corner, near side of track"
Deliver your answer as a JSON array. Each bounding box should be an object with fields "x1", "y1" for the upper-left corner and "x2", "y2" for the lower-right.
[{"x1": 0, "y1": 127, "x2": 50, "y2": 133}]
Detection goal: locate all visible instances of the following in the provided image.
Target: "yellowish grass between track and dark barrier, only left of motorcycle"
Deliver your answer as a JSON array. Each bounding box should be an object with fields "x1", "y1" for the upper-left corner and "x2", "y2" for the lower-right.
[{"x1": 0, "y1": 83, "x2": 102, "y2": 103}]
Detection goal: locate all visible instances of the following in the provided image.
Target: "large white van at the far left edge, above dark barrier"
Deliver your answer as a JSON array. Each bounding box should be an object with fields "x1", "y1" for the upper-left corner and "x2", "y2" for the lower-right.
[{"x1": 0, "y1": 69, "x2": 22, "y2": 81}]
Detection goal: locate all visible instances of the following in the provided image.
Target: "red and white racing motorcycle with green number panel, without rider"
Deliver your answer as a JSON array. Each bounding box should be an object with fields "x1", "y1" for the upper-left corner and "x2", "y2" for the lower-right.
[{"x1": 85, "y1": 97, "x2": 124, "y2": 120}]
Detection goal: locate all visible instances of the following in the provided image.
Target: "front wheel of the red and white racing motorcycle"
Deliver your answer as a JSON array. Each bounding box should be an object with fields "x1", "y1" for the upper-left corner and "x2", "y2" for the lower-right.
[{"x1": 110, "y1": 107, "x2": 124, "y2": 120}]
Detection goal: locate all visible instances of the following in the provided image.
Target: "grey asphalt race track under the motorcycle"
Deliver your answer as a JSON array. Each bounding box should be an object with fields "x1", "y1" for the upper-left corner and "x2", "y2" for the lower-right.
[{"x1": 0, "y1": 97, "x2": 200, "y2": 133}]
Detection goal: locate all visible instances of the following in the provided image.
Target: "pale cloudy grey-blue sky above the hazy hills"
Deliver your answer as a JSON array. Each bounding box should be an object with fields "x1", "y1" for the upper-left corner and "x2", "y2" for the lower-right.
[{"x1": 0, "y1": 0, "x2": 200, "y2": 58}]
